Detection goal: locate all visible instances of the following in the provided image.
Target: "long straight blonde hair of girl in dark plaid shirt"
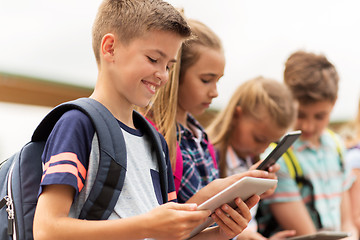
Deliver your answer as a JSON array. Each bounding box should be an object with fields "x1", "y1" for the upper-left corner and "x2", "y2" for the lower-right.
[{"x1": 145, "y1": 19, "x2": 223, "y2": 169}]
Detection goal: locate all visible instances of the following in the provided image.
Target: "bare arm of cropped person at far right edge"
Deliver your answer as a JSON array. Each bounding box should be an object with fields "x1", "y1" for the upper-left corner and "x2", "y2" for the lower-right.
[{"x1": 341, "y1": 190, "x2": 359, "y2": 240}]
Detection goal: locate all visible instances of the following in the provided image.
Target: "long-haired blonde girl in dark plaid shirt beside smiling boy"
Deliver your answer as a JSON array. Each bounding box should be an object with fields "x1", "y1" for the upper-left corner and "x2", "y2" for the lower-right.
[{"x1": 141, "y1": 20, "x2": 274, "y2": 239}]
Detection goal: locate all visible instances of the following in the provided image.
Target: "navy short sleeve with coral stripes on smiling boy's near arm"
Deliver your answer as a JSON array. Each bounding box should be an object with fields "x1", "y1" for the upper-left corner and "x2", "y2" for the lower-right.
[{"x1": 39, "y1": 110, "x2": 95, "y2": 196}]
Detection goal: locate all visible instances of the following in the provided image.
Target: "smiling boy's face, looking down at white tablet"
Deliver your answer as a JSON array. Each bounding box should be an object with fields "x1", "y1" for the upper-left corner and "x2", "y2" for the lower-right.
[{"x1": 109, "y1": 30, "x2": 183, "y2": 107}]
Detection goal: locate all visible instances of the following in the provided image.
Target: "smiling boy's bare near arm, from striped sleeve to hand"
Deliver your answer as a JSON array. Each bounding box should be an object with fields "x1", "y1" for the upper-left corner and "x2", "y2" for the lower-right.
[{"x1": 33, "y1": 185, "x2": 209, "y2": 240}]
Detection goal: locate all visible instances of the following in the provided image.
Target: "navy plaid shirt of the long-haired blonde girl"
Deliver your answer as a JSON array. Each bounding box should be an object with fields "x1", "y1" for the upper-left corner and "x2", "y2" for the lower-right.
[{"x1": 177, "y1": 115, "x2": 219, "y2": 203}]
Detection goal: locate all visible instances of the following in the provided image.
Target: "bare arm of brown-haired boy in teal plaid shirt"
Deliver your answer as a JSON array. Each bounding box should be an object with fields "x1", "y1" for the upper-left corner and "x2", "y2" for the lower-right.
[{"x1": 270, "y1": 201, "x2": 316, "y2": 235}]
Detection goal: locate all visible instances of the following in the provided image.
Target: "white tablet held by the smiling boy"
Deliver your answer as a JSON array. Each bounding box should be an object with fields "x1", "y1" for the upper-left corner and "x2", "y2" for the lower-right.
[{"x1": 190, "y1": 177, "x2": 277, "y2": 237}]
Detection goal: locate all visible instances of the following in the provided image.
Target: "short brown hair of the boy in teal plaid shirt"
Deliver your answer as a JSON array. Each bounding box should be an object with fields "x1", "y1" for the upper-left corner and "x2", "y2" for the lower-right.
[{"x1": 284, "y1": 51, "x2": 339, "y2": 104}]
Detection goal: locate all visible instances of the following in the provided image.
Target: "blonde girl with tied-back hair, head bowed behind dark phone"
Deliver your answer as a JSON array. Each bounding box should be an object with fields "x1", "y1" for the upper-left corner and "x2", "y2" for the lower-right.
[{"x1": 207, "y1": 77, "x2": 296, "y2": 239}]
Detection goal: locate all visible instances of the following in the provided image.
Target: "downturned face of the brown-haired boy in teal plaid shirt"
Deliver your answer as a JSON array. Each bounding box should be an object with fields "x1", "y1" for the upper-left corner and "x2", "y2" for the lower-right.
[{"x1": 295, "y1": 101, "x2": 334, "y2": 145}]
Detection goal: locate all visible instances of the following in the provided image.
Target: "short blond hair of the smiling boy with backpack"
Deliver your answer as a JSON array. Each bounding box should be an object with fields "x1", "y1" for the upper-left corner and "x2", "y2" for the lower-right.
[{"x1": 92, "y1": 0, "x2": 191, "y2": 64}]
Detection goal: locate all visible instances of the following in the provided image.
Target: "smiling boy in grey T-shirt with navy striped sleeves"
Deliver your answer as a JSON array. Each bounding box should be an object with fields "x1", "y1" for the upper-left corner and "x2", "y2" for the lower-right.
[{"x1": 33, "y1": 0, "x2": 256, "y2": 240}]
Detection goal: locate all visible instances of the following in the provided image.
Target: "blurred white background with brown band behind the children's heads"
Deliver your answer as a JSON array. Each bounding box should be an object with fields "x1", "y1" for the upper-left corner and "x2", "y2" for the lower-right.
[{"x1": 0, "y1": 0, "x2": 360, "y2": 160}]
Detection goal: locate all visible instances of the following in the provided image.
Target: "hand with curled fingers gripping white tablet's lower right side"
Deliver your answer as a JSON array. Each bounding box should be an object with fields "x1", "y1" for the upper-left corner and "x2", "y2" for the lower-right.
[{"x1": 211, "y1": 195, "x2": 260, "y2": 239}]
